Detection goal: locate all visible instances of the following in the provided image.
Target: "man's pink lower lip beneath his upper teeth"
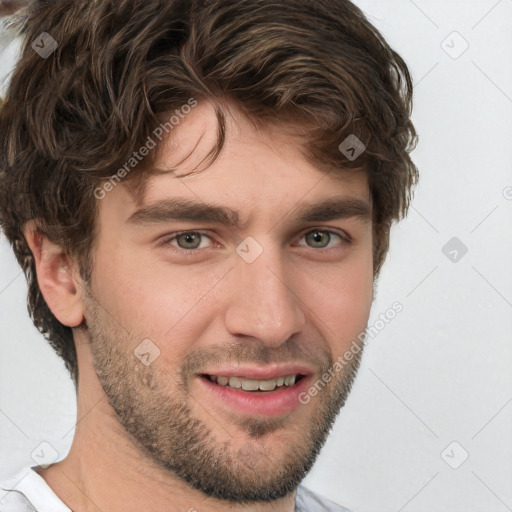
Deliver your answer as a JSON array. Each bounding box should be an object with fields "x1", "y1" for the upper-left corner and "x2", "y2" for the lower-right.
[{"x1": 198, "y1": 375, "x2": 311, "y2": 416}]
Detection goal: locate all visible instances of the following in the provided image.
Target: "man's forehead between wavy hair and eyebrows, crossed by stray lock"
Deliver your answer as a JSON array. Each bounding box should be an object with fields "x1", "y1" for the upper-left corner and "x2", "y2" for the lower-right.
[{"x1": 116, "y1": 102, "x2": 371, "y2": 225}]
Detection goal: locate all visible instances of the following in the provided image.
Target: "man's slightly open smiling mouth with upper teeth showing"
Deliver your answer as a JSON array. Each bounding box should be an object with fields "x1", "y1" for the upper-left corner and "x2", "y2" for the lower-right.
[{"x1": 197, "y1": 373, "x2": 313, "y2": 416}]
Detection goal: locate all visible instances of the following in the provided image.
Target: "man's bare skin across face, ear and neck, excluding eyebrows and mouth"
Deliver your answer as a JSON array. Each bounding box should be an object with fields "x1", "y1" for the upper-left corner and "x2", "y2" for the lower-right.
[{"x1": 25, "y1": 103, "x2": 373, "y2": 512}]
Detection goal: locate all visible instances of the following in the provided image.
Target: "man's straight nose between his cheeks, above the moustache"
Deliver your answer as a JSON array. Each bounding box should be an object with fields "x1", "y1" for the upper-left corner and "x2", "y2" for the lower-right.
[{"x1": 225, "y1": 241, "x2": 305, "y2": 347}]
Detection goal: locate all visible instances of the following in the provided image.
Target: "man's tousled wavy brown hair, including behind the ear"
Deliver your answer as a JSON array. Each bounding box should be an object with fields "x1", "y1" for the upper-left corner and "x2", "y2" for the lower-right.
[{"x1": 0, "y1": 0, "x2": 418, "y2": 385}]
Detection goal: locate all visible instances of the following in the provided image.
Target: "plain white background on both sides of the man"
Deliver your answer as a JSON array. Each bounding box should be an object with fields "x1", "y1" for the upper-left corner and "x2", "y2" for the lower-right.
[{"x1": 0, "y1": 0, "x2": 512, "y2": 512}]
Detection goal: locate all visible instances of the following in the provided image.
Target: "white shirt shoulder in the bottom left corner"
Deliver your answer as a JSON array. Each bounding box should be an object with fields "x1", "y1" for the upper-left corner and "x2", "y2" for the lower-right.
[{"x1": 0, "y1": 467, "x2": 71, "y2": 512}]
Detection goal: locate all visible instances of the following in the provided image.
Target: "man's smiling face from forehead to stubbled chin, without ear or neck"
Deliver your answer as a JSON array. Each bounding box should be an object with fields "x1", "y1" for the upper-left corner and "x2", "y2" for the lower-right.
[{"x1": 80, "y1": 104, "x2": 373, "y2": 502}]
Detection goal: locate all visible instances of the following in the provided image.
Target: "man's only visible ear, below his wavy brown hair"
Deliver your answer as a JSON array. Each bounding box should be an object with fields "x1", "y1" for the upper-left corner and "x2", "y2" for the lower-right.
[{"x1": 23, "y1": 220, "x2": 84, "y2": 327}]
